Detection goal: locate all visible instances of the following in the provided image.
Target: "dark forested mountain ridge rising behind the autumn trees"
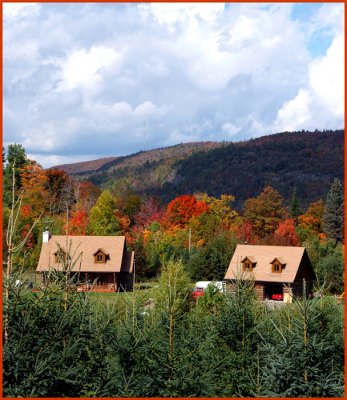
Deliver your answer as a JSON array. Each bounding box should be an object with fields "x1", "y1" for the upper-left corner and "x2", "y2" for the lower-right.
[{"x1": 55, "y1": 130, "x2": 344, "y2": 206}]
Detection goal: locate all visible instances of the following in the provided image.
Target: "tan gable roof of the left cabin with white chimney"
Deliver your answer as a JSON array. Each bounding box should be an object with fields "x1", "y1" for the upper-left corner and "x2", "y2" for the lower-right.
[{"x1": 36, "y1": 235, "x2": 134, "y2": 272}]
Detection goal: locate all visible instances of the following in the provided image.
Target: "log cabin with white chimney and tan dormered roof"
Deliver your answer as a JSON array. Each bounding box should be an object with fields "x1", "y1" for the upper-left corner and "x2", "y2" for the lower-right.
[{"x1": 36, "y1": 231, "x2": 134, "y2": 292}]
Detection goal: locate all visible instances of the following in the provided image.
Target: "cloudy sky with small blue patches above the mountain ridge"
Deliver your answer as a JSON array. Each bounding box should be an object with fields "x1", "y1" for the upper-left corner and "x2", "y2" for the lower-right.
[{"x1": 3, "y1": 3, "x2": 344, "y2": 167}]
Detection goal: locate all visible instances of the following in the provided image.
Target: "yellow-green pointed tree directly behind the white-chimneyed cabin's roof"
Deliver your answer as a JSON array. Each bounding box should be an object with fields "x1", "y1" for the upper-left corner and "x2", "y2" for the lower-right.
[{"x1": 89, "y1": 190, "x2": 122, "y2": 235}]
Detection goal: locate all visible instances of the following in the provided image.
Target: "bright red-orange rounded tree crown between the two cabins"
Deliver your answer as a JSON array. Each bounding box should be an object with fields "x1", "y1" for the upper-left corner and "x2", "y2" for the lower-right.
[{"x1": 167, "y1": 194, "x2": 209, "y2": 226}]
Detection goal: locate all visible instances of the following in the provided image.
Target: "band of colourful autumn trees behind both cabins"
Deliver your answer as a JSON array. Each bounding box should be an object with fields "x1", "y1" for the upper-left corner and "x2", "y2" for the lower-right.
[{"x1": 3, "y1": 144, "x2": 344, "y2": 293}]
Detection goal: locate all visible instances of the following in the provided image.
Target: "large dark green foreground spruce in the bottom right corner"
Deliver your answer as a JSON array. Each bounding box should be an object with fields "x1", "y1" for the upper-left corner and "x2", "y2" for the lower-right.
[{"x1": 258, "y1": 296, "x2": 343, "y2": 398}]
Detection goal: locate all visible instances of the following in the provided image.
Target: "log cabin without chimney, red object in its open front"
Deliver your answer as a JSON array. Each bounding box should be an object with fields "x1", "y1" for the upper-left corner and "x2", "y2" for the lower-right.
[{"x1": 224, "y1": 245, "x2": 316, "y2": 302}]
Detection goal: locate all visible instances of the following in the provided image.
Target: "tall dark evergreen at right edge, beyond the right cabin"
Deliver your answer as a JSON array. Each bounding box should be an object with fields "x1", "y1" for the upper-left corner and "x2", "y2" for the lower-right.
[{"x1": 323, "y1": 178, "x2": 344, "y2": 242}]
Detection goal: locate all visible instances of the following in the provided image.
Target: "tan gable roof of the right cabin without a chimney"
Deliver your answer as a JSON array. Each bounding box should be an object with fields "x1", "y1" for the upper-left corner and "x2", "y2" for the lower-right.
[{"x1": 224, "y1": 245, "x2": 305, "y2": 283}]
